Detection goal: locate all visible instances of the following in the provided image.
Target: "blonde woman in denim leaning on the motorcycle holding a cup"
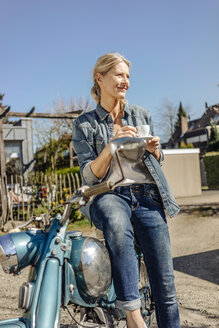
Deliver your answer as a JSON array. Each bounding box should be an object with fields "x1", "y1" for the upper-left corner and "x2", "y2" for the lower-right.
[{"x1": 73, "y1": 53, "x2": 180, "y2": 328}]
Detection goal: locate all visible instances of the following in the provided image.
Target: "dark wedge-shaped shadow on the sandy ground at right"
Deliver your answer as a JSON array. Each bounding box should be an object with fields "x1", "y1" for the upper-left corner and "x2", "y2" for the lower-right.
[{"x1": 173, "y1": 249, "x2": 219, "y2": 284}]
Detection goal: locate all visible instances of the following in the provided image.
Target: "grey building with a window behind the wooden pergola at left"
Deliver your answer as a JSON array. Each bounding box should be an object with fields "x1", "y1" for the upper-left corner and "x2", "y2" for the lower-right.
[{"x1": 3, "y1": 118, "x2": 33, "y2": 175}]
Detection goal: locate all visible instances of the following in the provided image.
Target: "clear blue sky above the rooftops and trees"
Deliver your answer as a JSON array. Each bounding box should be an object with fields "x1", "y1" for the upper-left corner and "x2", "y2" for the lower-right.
[{"x1": 0, "y1": 0, "x2": 219, "y2": 127}]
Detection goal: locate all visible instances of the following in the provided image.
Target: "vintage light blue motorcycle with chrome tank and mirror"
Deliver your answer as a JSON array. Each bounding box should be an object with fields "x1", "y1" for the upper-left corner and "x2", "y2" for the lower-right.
[{"x1": 0, "y1": 138, "x2": 154, "y2": 328}]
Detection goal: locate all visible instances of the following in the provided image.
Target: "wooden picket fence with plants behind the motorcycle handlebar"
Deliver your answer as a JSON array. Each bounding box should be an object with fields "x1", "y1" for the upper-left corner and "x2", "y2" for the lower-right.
[{"x1": 4, "y1": 173, "x2": 81, "y2": 220}]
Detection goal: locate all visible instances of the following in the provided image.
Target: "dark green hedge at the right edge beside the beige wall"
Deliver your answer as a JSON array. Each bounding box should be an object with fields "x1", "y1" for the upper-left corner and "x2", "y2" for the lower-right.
[{"x1": 204, "y1": 152, "x2": 219, "y2": 189}]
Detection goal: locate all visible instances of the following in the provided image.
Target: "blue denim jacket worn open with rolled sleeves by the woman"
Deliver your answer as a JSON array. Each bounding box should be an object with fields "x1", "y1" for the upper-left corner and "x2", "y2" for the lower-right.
[{"x1": 72, "y1": 104, "x2": 179, "y2": 219}]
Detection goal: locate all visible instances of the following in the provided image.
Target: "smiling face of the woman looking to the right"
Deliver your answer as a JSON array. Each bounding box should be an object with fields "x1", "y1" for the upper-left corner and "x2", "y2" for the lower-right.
[{"x1": 96, "y1": 62, "x2": 129, "y2": 100}]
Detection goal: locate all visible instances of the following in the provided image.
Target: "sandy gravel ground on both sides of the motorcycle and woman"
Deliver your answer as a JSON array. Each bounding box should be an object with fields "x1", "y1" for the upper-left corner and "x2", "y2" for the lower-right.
[{"x1": 0, "y1": 214, "x2": 219, "y2": 328}]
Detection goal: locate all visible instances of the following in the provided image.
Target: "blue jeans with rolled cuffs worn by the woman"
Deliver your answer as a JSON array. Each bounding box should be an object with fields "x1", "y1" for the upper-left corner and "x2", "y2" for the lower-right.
[{"x1": 91, "y1": 184, "x2": 180, "y2": 328}]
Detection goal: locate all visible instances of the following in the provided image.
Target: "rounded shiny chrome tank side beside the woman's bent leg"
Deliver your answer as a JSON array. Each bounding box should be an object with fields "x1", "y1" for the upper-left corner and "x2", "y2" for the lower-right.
[{"x1": 71, "y1": 237, "x2": 112, "y2": 298}]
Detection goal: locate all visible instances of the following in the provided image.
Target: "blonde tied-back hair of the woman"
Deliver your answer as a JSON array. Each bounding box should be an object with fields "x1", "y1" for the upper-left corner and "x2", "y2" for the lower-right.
[{"x1": 91, "y1": 52, "x2": 131, "y2": 104}]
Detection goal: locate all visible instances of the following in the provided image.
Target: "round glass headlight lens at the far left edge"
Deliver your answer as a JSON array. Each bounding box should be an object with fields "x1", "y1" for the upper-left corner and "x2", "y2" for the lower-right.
[{"x1": 0, "y1": 235, "x2": 18, "y2": 273}]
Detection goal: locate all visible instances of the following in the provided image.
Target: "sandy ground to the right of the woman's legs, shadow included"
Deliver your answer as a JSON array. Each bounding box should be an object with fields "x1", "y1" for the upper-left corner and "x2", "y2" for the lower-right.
[{"x1": 152, "y1": 190, "x2": 219, "y2": 328}]
